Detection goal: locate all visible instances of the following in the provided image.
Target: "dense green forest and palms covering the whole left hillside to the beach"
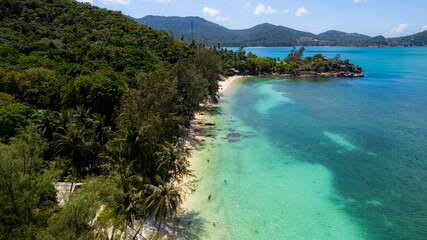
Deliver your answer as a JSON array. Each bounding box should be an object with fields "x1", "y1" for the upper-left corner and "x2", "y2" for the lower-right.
[{"x1": 0, "y1": 0, "x2": 221, "y2": 239}]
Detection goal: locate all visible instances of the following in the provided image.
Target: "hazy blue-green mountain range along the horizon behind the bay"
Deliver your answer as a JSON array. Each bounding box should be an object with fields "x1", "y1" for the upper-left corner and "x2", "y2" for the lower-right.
[{"x1": 131, "y1": 15, "x2": 427, "y2": 47}]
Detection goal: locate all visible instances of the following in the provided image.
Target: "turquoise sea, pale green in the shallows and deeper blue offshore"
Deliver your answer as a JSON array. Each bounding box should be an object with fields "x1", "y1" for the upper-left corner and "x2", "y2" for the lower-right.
[{"x1": 179, "y1": 47, "x2": 427, "y2": 240}]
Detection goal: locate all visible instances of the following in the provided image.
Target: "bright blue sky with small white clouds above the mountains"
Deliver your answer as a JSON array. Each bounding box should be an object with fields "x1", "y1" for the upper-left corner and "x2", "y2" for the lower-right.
[{"x1": 78, "y1": 0, "x2": 427, "y2": 37}]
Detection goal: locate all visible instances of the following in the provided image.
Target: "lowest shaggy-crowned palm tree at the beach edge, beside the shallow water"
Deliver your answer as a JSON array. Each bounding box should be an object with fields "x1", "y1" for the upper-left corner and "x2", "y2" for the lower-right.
[{"x1": 144, "y1": 175, "x2": 183, "y2": 231}]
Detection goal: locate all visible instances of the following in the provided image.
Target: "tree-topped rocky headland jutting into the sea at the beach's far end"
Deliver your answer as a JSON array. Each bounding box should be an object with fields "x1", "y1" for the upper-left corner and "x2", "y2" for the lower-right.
[{"x1": 224, "y1": 47, "x2": 364, "y2": 78}]
